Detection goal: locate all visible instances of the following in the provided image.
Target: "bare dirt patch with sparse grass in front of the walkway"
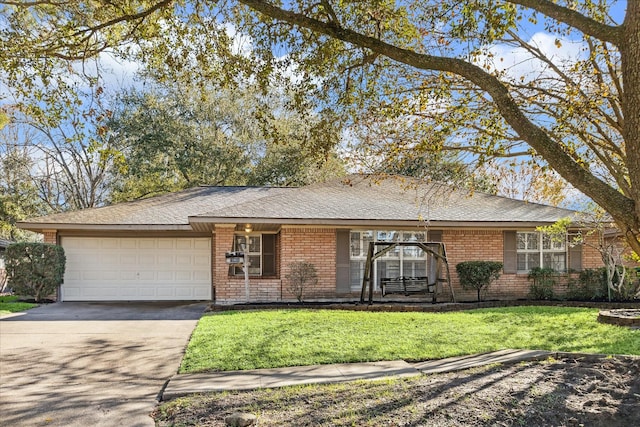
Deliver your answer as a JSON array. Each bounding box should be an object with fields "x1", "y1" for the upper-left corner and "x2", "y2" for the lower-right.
[{"x1": 153, "y1": 357, "x2": 640, "y2": 427}]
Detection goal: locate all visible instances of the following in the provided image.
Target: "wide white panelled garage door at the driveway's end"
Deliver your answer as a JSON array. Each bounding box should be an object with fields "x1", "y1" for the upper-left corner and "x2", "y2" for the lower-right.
[{"x1": 61, "y1": 237, "x2": 211, "y2": 301}]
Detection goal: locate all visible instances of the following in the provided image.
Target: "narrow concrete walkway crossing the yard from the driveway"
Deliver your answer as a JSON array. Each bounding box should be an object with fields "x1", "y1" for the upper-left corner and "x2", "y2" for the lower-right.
[{"x1": 161, "y1": 350, "x2": 555, "y2": 400}]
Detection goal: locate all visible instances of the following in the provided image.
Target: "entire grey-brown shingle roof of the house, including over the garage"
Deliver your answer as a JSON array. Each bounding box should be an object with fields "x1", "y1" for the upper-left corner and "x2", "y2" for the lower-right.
[{"x1": 17, "y1": 176, "x2": 574, "y2": 230}]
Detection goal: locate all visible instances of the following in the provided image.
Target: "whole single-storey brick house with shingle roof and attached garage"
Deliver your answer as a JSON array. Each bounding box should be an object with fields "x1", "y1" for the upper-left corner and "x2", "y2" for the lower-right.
[{"x1": 19, "y1": 175, "x2": 601, "y2": 304}]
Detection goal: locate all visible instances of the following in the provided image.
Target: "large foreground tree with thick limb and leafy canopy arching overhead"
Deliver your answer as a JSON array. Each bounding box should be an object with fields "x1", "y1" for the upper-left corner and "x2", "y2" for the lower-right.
[{"x1": 0, "y1": 0, "x2": 640, "y2": 253}]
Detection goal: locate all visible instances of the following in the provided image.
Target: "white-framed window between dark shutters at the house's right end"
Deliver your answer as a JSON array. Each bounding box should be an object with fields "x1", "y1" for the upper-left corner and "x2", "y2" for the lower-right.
[{"x1": 516, "y1": 231, "x2": 567, "y2": 272}]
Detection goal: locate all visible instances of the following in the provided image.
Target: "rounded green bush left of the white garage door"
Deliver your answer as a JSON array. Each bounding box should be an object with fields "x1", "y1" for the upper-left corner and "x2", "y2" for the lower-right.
[{"x1": 5, "y1": 242, "x2": 66, "y2": 302}]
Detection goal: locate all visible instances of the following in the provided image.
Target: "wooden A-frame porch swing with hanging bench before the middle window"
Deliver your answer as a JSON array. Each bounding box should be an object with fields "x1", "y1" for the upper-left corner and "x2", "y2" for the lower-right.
[{"x1": 360, "y1": 242, "x2": 456, "y2": 305}]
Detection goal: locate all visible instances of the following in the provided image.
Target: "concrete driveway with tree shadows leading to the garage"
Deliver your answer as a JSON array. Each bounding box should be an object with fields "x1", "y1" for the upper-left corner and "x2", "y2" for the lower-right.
[{"x1": 0, "y1": 303, "x2": 206, "y2": 427}]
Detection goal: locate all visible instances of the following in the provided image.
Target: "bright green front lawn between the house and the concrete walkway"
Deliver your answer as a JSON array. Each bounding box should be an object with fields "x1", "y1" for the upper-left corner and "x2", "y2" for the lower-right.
[{"x1": 180, "y1": 307, "x2": 640, "y2": 373}]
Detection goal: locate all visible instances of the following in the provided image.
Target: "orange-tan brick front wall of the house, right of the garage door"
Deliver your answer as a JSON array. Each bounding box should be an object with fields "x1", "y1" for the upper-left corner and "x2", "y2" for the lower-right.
[{"x1": 212, "y1": 226, "x2": 602, "y2": 304}]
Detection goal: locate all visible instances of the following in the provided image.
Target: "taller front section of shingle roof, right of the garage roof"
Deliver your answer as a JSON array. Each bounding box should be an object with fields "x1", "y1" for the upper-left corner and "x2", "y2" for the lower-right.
[{"x1": 196, "y1": 177, "x2": 574, "y2": 222}]
